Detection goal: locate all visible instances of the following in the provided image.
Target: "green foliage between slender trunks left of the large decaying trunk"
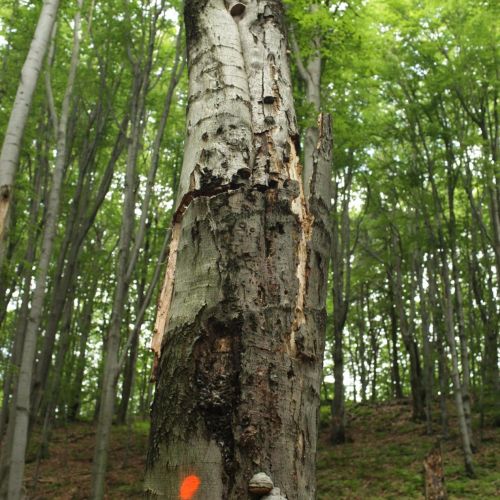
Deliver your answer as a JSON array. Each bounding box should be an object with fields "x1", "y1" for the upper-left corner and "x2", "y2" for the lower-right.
[{"x1": 0, "y1": 0, "x2": 187, "y2": 417}]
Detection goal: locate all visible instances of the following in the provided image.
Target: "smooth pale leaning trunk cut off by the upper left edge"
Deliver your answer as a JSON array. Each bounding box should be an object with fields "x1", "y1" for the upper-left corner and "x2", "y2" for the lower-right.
[{"x1": 0, "y1": 0, "x2": 59, "y2": 269}]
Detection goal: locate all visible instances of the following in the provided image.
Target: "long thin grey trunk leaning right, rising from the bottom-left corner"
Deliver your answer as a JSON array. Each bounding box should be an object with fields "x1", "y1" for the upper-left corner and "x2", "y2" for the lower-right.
[{"x1": 7, "y1": 0, "x2": 83, "y2": 500}]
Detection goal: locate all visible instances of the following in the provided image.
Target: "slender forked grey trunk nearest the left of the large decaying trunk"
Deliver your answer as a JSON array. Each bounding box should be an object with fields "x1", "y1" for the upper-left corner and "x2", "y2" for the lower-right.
[{"x1": 92, "y1": 10, "x2": 183, "y2": 492}]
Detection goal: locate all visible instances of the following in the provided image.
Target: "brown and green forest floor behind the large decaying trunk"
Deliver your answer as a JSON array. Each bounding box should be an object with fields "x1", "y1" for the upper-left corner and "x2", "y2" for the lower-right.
[{"x1": 21, "y1": 402, "x2": 500, "y2": 500}]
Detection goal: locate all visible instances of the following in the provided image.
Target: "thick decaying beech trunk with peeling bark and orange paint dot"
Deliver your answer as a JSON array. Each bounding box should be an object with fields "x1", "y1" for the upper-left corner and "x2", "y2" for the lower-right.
[{"x1": 146, "y1": 0, "x2": 331, "y2": 500}]
